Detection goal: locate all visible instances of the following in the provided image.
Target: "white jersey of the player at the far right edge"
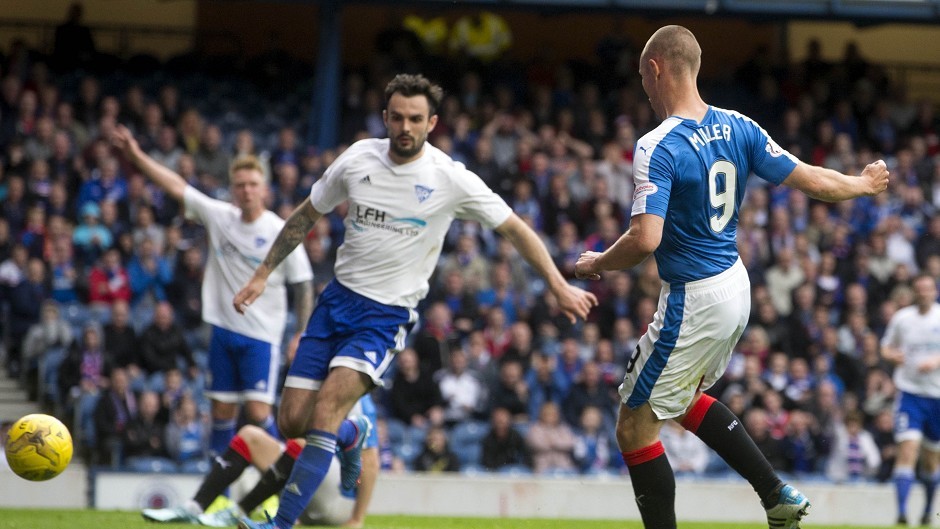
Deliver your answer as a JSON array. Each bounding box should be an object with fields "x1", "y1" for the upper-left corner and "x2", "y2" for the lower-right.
[{"x1": 881, "y1": 303, "x2": 940, "y2": 398}]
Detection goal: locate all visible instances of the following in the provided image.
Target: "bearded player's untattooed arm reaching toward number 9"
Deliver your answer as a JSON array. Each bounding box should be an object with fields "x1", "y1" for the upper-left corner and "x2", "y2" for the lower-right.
[{"x1": 496, "y1": 213, "x2": 597, "y2": 323}]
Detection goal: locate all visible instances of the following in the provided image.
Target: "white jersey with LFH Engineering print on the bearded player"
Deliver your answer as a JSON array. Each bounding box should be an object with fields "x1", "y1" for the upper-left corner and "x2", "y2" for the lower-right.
[{"x1": 310, "y1": 139, "x2": 512, "y2": 308}]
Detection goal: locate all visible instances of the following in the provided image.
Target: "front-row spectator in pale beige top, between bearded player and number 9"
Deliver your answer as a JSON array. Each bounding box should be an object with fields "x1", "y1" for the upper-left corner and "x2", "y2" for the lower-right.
[{"x1": 526, "y1": 401, "x2": 576, "y2": 474}]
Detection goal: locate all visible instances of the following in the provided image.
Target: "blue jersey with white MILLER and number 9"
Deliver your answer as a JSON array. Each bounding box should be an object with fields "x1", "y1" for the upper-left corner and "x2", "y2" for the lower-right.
[{"x1": 632, "y1": 107, "x2": 797, "y2": 283}]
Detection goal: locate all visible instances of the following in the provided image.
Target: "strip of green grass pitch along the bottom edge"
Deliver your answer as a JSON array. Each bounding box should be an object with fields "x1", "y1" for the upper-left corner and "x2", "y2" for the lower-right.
[{"x1": 0, "y1": 509, "x2": 896, "y2": 529}]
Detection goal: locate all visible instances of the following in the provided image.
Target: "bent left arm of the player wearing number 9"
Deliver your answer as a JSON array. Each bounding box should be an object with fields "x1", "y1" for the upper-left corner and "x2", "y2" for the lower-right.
[{"x1": 574, "y1": 213, "x2": 663, "y2": 279}]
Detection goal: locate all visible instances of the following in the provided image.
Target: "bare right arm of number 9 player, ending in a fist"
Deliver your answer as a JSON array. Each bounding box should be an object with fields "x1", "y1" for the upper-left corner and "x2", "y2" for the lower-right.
[{"x1": 783, "y1": 160, "x2": 888, "y2": 202}]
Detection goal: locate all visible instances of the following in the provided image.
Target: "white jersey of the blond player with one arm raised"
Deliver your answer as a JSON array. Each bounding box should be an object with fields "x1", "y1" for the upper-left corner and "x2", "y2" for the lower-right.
[{"x1": 183, "y1": 186, "x2": 313, "y2": 346}]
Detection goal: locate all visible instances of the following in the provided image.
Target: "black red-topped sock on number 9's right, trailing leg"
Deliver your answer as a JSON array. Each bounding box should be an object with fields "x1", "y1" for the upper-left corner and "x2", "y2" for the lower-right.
[{"x1": 682, "y1": 394, "x2": 783, "y2": 508}]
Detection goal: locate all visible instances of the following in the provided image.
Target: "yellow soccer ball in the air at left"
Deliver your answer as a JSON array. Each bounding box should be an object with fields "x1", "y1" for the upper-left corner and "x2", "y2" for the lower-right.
[{"x1": 6, "y1": 413, "x2": 72, "y2": 481}]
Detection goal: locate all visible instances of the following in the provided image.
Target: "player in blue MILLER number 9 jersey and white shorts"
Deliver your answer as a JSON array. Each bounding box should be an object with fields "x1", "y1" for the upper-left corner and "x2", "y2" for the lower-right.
[{"x1": 575, "y1": 26, "x2": 888, "y2": 529}]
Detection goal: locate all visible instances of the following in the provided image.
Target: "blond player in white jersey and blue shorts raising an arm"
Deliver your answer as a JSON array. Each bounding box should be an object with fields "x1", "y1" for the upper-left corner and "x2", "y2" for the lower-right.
[{"x1": 112, "y1": 126, "x2": 313, "y2": 454}]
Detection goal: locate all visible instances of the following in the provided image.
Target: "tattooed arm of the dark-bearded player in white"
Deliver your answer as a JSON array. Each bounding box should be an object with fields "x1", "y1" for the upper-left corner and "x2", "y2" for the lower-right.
[{"x1": 232, "y1": 200, "x2": 322, "y2": 314}]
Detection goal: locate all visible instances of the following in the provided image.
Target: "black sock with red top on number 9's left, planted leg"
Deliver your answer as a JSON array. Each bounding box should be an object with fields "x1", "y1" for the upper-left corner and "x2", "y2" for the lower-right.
[{"x1": 622, "y1": 441, "x2": 676, "y2": 529}]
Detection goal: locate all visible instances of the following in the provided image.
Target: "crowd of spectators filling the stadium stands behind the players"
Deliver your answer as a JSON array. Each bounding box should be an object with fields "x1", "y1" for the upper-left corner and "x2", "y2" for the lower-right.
[{"x1": 0, "y1": 15, "x2": 940, "y2": 481}]
